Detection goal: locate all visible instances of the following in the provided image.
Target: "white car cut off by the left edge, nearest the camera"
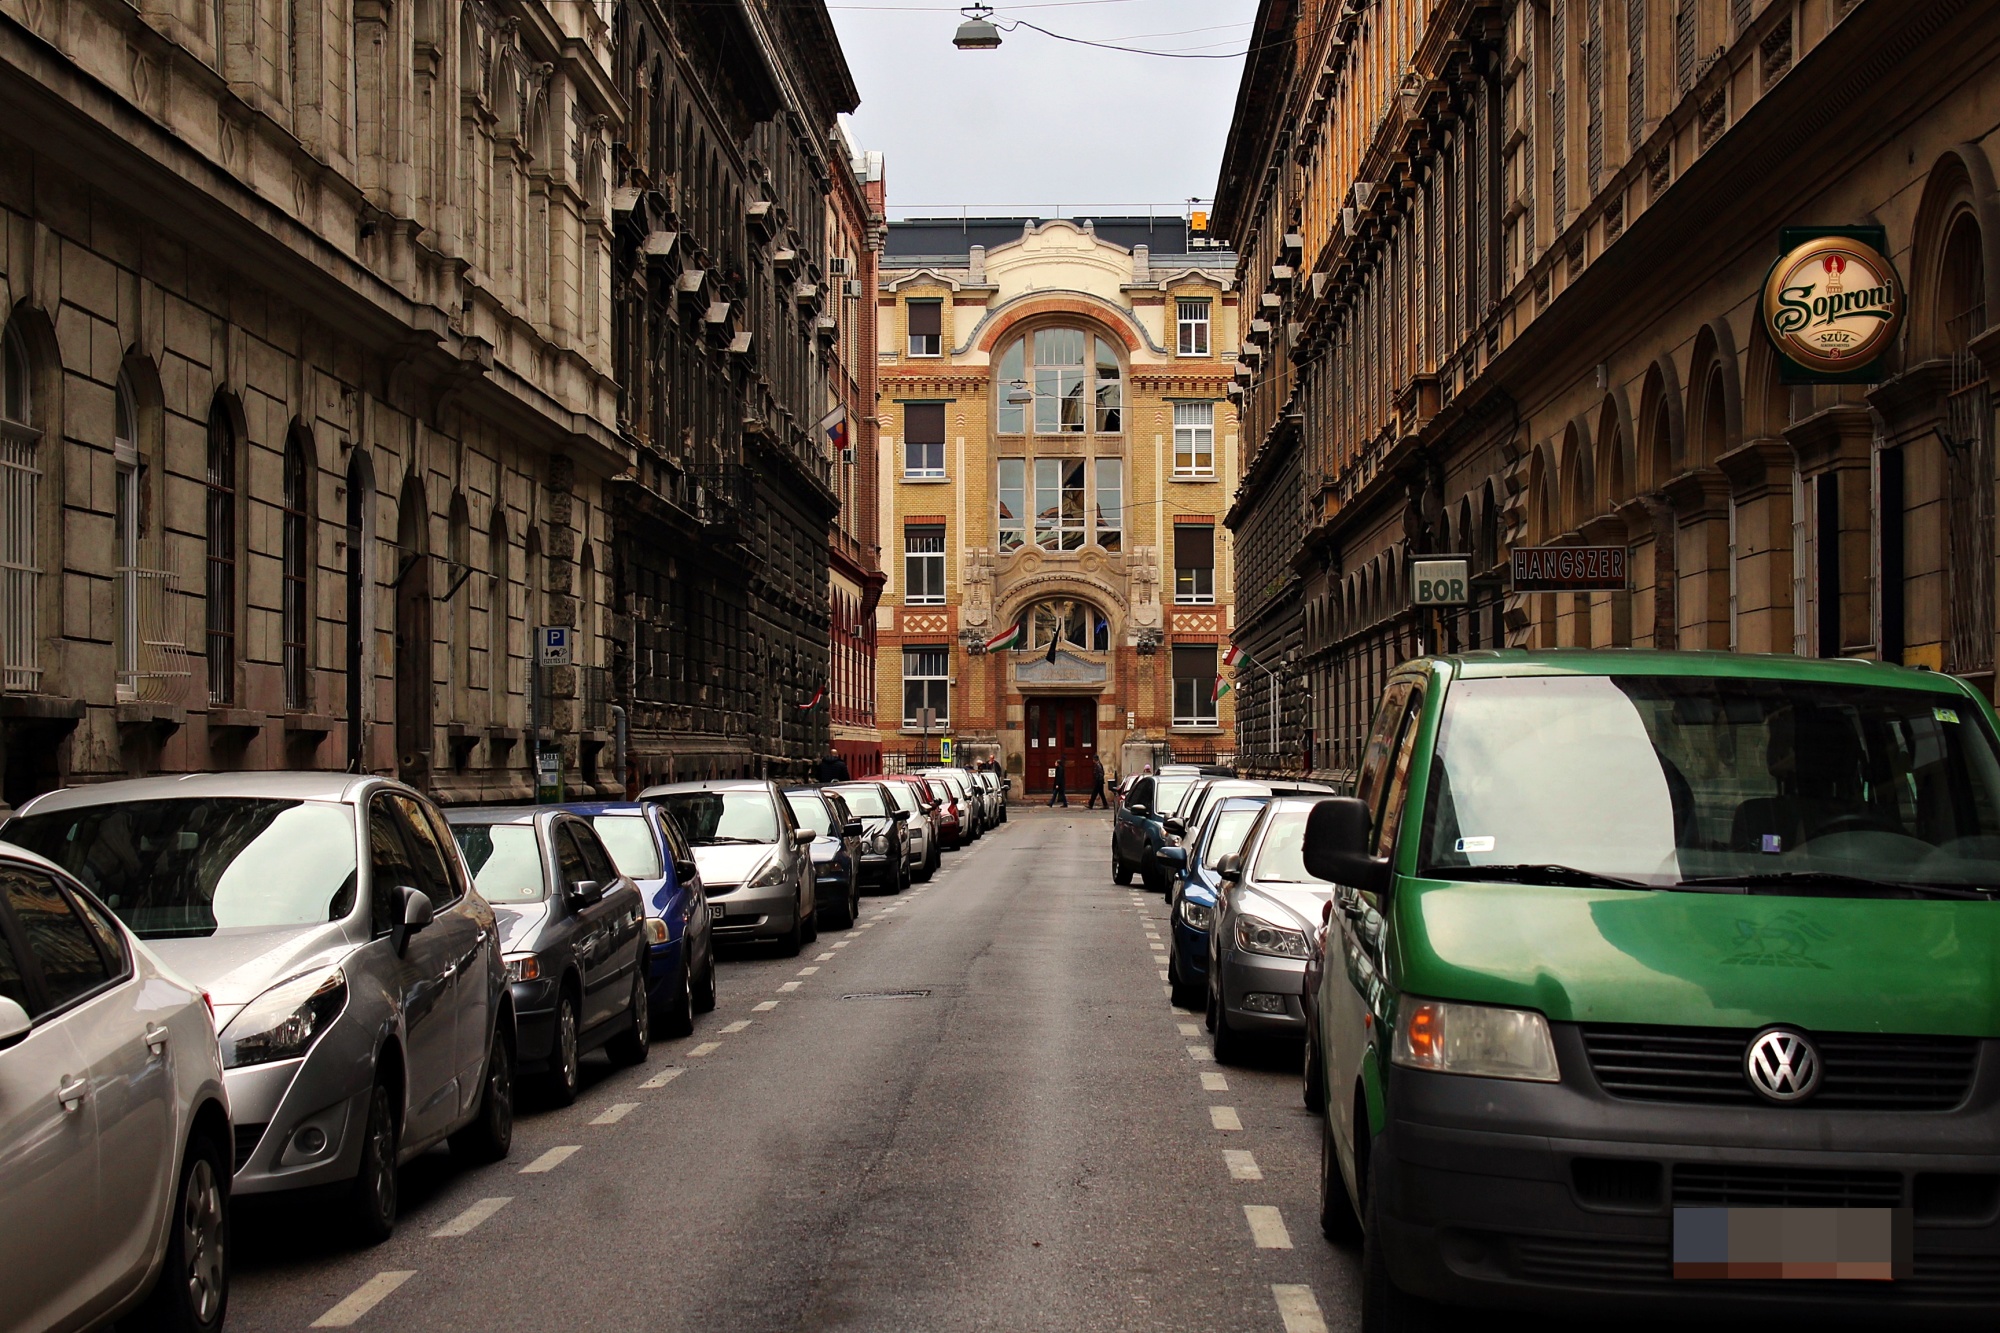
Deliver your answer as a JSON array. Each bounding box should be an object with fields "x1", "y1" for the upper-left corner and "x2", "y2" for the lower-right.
[{"x1": 0, "y1": 843, "x2": 234, "y2": 1333}]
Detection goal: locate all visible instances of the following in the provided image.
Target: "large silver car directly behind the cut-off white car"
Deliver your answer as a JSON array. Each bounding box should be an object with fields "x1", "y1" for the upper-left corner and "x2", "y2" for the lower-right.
[{"x1": 0, "y1": 773, "x2": 514, "y2": 1241}]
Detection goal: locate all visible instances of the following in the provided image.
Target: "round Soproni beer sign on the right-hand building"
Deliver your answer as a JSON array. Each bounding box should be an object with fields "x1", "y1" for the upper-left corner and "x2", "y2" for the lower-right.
[{"x1": 1764, "y1": 236, "x2": 1902, "y2": 374}]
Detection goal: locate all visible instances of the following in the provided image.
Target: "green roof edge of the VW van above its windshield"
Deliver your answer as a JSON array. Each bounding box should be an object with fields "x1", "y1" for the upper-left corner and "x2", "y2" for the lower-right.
[{"x1": 1430, "y1": 648, "x2": 1970, "y2": 695}]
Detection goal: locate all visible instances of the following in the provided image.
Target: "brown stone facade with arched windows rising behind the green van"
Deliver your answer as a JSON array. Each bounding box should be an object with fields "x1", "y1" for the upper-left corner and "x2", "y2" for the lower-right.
[{"x1": 1216, "y1": 0, "x2": 2000, "y2": 775}]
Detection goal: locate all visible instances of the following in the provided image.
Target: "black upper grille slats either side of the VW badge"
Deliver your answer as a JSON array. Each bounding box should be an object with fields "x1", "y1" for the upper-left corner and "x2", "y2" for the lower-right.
[{"x1": 1582, "y1": 1023, "x2": 1980, "y2": 1111}]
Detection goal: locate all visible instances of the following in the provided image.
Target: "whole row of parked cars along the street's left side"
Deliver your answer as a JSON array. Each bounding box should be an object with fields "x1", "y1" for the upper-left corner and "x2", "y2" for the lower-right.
[{"x1": 0, "y1": 769, "x2": 1006, "y2": 1331}]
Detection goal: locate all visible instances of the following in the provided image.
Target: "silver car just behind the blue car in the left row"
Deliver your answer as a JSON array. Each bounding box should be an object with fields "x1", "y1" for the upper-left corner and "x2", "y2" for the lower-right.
[{"x1": 638, "y1": 779, "x2": 820, "y2": 955}]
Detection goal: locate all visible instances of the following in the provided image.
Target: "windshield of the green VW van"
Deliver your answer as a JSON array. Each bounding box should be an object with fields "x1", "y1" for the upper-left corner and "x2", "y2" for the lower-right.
[{"x1": 1420, "y1": 677, "x2": 2000, "y2": 889}]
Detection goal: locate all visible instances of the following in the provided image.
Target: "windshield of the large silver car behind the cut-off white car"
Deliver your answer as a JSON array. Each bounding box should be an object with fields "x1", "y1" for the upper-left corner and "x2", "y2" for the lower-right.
[{"x1": 0, "y1": 797, "x2": 354, "y2": 939}]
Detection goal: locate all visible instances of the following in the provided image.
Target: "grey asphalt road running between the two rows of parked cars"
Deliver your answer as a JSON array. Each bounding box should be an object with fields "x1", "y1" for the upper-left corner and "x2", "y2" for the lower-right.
[{"x1": 230, "y1": 807, "x2": 1358, "y2": 1333}]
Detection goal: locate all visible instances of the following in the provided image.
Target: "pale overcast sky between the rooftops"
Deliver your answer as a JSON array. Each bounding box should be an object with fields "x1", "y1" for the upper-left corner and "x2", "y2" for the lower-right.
[{"x1": 826, "y1": 0, "x2": 1256, "y2": 218}]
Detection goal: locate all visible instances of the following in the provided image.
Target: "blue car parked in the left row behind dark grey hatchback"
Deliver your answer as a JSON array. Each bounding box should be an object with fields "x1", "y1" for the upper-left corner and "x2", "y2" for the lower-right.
[{"x1": 560, "y1": 801, "x2": 716, "y2": 1037}]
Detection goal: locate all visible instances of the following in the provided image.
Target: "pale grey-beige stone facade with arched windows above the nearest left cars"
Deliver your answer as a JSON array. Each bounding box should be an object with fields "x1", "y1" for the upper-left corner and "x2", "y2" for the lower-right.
[{"x1": 0, "y1": 0, "x2": 628, "y2": 801}]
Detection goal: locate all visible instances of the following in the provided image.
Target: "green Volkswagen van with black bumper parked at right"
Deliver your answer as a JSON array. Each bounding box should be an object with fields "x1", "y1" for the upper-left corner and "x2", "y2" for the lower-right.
[{"x1": 1306, "y1": 650, "x2": 2000, "y2": 1333}]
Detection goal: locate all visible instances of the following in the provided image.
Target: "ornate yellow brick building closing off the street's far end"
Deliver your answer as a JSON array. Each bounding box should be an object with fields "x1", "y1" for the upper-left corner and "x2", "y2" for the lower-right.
[{"x1": 876, "y1": 218, "x2": 1238, "y2": 793}]
